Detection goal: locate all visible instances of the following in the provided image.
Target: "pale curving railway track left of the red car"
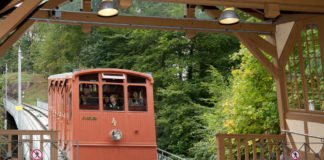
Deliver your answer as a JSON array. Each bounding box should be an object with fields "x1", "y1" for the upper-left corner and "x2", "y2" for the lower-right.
[{"x1": 23, "y1": 104, "x2": 48, "y2": 130}]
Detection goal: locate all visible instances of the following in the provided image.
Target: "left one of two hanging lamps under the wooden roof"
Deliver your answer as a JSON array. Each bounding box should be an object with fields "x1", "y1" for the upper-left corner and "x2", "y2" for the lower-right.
[{"x1": 98, "y1": 0, "x2": 119, "y2": 17}]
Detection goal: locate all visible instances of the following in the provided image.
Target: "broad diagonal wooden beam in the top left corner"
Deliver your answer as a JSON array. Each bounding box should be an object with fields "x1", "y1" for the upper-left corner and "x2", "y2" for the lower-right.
[{"x1": 0, "y1": 0, "x2": 42, "y2": 40}]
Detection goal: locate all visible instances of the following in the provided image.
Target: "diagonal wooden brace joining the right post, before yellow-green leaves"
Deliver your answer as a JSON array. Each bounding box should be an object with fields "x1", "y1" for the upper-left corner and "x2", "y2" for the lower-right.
[{"x1": 235, "y1": 33, "x2": 278, "y2": 78}]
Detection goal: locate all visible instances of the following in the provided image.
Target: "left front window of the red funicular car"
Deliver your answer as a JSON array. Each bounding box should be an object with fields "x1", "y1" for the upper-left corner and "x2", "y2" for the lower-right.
[{"x1": 79, "y1": 84, "x2": 99, "y2": 110}]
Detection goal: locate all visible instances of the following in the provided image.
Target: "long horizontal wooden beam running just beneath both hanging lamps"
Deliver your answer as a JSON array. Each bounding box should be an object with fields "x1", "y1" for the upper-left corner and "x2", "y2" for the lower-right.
[{"x1": 32, "y1": 10, "x2": 275, "y2": 34}]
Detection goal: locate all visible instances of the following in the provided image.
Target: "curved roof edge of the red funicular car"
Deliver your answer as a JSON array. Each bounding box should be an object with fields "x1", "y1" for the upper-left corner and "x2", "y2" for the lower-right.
[{"x1": 48, "y1": 68, "x2": 153, "y2": 82}]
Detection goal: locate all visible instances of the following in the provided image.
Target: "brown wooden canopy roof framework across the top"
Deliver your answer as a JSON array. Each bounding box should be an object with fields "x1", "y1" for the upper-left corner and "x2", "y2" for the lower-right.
[{"x1": 0, "y1": 0, "x2": 324, "y2": 55}]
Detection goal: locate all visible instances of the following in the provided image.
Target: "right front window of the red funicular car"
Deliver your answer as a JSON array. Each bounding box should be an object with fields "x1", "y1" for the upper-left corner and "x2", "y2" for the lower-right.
[{"x1": 128, "y1": 86, "x2": 147, "y2": 111}]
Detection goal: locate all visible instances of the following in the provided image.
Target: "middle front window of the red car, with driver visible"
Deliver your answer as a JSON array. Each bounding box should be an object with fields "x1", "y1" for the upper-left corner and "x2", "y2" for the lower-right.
[{"x1": 102, "y1": 84, "x2": 124, "y2": 111}]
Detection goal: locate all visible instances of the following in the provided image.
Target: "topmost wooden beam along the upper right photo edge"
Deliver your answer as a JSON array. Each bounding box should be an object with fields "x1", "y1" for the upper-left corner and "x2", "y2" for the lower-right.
[{"x1": 146, "y1": 0, "x2": 324, "y2": 13}]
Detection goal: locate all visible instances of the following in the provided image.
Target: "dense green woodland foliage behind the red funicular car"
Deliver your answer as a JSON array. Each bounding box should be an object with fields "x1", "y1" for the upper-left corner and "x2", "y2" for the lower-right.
[{"x1": 0, "y1": 3, "x2": 279, "y2": 159}]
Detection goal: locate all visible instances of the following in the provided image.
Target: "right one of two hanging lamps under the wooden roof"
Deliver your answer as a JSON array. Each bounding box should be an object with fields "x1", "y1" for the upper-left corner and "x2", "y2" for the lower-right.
[{"x1": 219, "y1": 7, "x2": 240, "y2": 24}]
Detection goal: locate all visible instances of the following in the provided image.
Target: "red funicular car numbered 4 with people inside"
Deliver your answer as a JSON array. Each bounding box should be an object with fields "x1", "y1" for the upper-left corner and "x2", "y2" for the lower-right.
[{"x1": 48, "y1": 69, "x2": 157, "y2": 160}]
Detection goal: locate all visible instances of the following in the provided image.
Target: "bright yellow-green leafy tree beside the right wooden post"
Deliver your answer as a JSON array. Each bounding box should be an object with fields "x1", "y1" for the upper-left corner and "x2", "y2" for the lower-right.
[{"x1": 223, "y1": 47, "x2": 280, "y2": 134}]
